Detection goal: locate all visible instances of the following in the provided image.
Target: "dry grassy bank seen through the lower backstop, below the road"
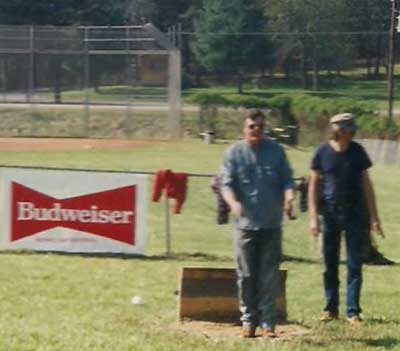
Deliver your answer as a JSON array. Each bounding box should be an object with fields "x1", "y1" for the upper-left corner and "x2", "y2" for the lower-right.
[{"x1": 0, "y1": 106, "x2": 206, "y2": 139}]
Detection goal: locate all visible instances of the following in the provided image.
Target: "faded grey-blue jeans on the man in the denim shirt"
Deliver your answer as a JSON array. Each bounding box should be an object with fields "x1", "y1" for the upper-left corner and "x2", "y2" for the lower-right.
[{"x1": 235, "y1": 228, "x2": 282, "y2": 329}]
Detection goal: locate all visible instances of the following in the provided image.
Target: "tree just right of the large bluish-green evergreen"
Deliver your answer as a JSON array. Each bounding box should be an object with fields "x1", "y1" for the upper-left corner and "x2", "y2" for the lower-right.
[{"x1": 265, "y1": 0, "x2": 353, "y2": 90}]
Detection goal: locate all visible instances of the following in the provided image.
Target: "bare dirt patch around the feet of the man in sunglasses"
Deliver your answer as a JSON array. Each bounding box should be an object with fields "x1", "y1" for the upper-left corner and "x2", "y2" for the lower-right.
[{"x1": 178, "y1": 321, "x2": 310, "y2": 341}]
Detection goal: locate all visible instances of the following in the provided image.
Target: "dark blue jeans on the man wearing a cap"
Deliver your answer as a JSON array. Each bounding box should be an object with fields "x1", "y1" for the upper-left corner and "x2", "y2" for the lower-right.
[{"x1": 321, "y1": 211, "x2": 368, "y2": 317}]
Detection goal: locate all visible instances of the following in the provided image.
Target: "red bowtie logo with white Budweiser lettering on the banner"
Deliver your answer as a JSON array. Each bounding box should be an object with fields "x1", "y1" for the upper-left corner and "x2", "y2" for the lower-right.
[{"x1": 11, "y1": 182, "x2": 136, "y2": 245}]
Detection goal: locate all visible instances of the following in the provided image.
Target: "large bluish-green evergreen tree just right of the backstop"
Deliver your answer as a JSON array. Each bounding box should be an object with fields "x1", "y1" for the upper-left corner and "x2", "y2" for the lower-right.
[{"x1": 195, "y1": 0, "x2": 270, "y2": 93}]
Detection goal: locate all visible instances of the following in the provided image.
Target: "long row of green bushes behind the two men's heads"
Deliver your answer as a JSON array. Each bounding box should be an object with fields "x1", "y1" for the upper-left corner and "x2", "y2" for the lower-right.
[{"x1": 188, "y1": 92, "x2": 400, "y2": 144}]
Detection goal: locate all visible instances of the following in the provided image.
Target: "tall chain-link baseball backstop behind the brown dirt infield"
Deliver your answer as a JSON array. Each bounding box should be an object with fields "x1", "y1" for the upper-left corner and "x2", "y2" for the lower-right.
[{"x1": 0, "y1": 24, "x2": 181, "y2": 138}]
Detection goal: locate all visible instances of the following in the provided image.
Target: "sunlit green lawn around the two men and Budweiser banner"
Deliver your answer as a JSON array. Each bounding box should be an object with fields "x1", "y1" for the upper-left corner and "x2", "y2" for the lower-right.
[{"x1": 0, "y1": 141, "x2": 400, "y2": 351}]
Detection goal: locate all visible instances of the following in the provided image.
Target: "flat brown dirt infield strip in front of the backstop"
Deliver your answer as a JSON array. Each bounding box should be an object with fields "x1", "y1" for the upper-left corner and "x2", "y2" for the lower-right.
[{"x1": 0, "y1": 138, "x2": 155, "y2": 151}]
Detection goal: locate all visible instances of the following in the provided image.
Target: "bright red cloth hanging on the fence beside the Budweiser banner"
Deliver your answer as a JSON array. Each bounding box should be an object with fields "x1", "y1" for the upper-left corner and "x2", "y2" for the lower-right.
[{"x1": 152, "y1": 169, "x2": 188, "y2": 214}]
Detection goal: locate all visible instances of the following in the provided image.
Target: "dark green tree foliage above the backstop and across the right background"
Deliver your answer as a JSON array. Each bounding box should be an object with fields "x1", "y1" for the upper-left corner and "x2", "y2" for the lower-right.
[{"x1": 0, "y1": 0, "x2": 394, "y2": 91}]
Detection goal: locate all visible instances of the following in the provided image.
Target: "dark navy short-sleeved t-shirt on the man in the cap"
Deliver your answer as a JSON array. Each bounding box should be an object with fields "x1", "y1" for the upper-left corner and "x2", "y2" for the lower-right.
[{"x1": 311, "y1": 142, "x2": 372, "y2": 209}]
